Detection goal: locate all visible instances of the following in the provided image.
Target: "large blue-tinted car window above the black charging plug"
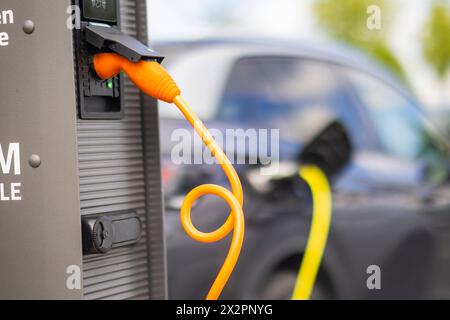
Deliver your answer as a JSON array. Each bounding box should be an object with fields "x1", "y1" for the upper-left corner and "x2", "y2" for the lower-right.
[{"x1": 218, "y1": 57, "x2": 370, "y2": 147}]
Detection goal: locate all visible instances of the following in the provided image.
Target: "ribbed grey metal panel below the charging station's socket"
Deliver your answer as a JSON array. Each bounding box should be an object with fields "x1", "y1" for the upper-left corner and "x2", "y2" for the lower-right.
[{"x1": 78, "y1": 0, "x2": 164, "y2": 299}]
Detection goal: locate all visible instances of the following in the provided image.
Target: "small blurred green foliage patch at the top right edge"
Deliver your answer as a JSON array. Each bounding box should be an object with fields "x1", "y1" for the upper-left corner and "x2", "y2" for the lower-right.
[{"x1": 422, "y1": 1, "x2": 450, "y2": 79}]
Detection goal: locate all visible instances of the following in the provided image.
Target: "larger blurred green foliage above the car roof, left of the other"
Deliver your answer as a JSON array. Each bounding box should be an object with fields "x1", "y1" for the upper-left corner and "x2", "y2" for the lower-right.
[{"x1": 313, "y1": 0, "x2": 406, "y2": 80}]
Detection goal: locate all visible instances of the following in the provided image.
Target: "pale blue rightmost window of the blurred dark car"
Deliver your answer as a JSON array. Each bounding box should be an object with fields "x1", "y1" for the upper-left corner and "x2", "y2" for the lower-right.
[{"x1": 347, "y1": 70, "x2": 448, "y2": 184}]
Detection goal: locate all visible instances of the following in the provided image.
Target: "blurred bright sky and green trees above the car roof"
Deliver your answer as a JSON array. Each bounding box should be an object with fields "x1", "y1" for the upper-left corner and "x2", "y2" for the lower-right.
[{"x1": 148, "y1": 0, "x2": 450, "y2": 111}]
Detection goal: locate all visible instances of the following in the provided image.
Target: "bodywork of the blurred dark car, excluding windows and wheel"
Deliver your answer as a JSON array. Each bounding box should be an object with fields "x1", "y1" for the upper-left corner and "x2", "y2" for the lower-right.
[{"x1": 157, "y1": 40, "x2": 450, "y2": 299}]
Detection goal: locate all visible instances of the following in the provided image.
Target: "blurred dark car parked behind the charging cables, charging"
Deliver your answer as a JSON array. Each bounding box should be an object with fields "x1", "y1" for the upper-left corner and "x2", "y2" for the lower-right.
[{"x1": 157, "y1": 40, "x2": 450, "y2": 299}]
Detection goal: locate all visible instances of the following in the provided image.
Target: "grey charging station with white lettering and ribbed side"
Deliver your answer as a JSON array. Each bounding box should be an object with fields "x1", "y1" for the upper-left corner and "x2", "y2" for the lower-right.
[{"x1": 0, "y1": 0, "x2": 166, "y2": 299}]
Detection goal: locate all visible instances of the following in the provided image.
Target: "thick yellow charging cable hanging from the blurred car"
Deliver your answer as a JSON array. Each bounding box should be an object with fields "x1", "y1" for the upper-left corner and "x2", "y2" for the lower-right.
[{"x1": 292, "y1": 165, "x2": 332, "y2": 300}]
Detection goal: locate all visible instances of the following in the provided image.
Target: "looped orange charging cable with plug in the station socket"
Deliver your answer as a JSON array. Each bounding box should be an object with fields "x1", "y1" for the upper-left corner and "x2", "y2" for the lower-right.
[{"x1": 94, "y1": 53, "x2": 245, "y2": 300}]
